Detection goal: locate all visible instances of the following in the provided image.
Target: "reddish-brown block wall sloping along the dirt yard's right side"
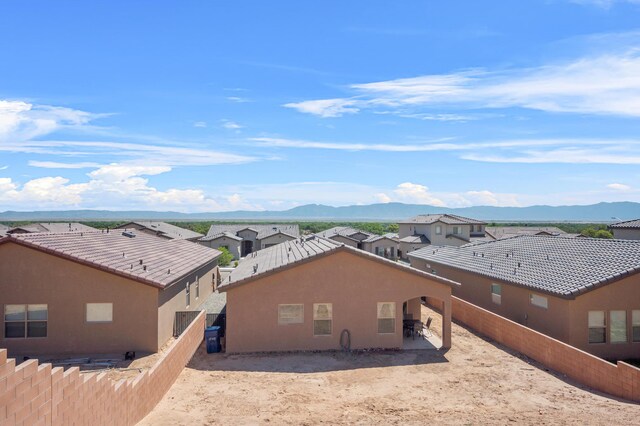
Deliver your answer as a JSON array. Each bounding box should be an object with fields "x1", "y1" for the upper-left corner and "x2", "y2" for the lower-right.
[{"x1": 451, "y1": 297, "x2": 640, "y2": 402}]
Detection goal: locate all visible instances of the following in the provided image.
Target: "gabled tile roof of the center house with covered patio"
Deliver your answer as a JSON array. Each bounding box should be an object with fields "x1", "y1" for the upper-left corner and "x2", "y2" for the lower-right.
[{"x1": 218, "y1": 236, "x2": 459, "y2": 292}]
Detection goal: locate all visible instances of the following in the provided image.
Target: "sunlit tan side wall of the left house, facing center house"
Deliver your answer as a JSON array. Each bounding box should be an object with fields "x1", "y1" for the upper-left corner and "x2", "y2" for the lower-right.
[{"x1": 157, "y1": 261, "x2": 219, "y2": 348}]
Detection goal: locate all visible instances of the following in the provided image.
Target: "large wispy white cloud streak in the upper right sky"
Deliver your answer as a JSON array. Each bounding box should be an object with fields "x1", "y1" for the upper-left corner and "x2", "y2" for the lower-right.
[{"x1": 285, "y1": 47, "x2": 640, "y2": 118}]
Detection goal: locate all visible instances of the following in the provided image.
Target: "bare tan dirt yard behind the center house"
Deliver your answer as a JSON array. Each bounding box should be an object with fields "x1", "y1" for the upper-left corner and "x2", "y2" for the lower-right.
[{"x1": 141, "y1": 308, "x2": 640, "y2": 425}]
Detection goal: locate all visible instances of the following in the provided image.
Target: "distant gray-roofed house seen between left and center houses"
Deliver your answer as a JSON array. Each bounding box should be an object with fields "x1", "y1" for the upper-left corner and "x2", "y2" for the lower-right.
[{"x1": 198, "y1": 223, "x2": 300, "y2": 259}]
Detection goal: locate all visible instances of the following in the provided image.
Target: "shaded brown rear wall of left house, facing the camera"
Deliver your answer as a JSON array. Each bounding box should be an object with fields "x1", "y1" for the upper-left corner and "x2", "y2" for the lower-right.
[{"x1": 0, "y1": 242, "x2": 158, "y2": 356}]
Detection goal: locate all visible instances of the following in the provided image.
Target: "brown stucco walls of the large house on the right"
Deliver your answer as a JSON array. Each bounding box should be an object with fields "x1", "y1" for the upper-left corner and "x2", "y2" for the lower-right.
[{"x1": 411, "y1": 258, "x2": 640, "y2": 359}]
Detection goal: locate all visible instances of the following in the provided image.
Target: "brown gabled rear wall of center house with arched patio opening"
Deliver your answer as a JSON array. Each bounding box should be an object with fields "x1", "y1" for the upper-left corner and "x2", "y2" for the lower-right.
[{"x1": 226, "y1": 251, "x2": 451, "y2": 353}]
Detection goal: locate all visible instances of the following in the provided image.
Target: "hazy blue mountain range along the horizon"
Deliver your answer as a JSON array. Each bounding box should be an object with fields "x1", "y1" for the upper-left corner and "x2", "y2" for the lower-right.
[{"x1": 0, "y1": 202, "x2": 640, "y2": 222}]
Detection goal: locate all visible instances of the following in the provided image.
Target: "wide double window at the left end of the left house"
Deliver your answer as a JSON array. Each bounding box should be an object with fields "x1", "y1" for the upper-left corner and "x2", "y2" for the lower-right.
[{"x1": 4, "y1": 305, "x2": 49, "y2": 338}]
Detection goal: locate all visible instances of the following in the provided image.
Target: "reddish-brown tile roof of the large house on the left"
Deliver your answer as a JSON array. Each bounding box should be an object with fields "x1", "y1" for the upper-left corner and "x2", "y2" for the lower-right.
[{"x1": 0, "y1": 230, "x2": 221, "y2": 288}]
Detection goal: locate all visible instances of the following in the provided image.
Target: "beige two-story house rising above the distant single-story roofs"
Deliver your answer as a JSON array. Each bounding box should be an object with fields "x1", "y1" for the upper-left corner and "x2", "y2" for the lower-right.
[{"x1": 398, "y1": 214, "x2": 494, "y2": 259}]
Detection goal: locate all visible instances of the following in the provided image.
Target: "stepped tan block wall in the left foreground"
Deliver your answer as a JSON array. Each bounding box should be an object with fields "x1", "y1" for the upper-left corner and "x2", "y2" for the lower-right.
[{"x1": 0, "y1": 312, "x2": 206, "y2": 425}]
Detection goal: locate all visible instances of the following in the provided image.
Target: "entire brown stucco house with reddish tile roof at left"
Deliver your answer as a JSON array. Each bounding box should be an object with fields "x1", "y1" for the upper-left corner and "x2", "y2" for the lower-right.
[{"x1": 0, "y1": 230, "x2": 221, "y2": 356}]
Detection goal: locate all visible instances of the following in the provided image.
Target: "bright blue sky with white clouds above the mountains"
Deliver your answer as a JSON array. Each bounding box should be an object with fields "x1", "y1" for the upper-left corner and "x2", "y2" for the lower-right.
[{"x1": 0, "y1": 0, "x2": 640, "y2": 212}]
